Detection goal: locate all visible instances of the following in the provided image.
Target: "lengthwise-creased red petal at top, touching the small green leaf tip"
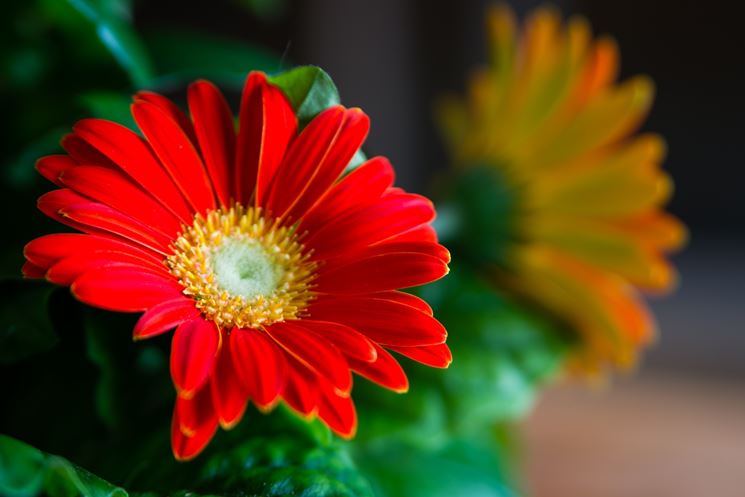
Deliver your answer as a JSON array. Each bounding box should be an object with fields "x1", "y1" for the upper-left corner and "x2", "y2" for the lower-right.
[{"x1": 234, "y1": 71, "x2": 297, "y2": 206}]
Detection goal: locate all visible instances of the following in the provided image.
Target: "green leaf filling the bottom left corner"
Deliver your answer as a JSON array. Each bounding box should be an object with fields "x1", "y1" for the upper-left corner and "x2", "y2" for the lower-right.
[{"x1": 0, "y1": 435, "x2": 128, "y2": 497}]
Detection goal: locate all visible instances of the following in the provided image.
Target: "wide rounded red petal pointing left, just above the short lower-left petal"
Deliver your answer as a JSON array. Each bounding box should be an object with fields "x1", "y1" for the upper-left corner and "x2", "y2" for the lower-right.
[{"x1": 70, "y1": 265, "x2": 183, "y2": 312}]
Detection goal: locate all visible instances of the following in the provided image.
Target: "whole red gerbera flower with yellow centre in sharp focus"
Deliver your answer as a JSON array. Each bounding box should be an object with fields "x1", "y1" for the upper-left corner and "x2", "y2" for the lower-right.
[{"x1": 24, "y1": 72, "x2": 451, "y2": 459}]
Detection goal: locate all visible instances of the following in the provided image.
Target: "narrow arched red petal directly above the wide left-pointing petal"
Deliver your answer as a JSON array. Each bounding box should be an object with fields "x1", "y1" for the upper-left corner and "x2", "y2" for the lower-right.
[{"x1": 46, "y1": 250, "x2": 169, "y2": 286}]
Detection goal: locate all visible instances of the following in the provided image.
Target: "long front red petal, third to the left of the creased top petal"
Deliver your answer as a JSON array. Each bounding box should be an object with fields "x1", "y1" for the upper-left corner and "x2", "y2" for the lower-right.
[{"x1": 73, "y1": 119, "x2": 193, "y2": 224}]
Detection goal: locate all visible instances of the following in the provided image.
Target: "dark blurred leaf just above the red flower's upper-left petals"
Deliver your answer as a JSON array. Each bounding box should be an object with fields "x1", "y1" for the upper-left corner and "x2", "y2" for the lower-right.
[{"x1": 145, "y1": 29, "x2": 280, "y2": 89}]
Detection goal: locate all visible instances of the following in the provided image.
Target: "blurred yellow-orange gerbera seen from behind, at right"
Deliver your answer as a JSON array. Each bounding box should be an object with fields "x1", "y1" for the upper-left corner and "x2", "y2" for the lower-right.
[{"x1": 439, "y1": 5, "x2": 686, "y2": 374}]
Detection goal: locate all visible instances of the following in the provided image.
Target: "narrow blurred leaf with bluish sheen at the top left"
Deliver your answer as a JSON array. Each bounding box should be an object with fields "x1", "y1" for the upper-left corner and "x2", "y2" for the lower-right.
[{"x1": 67, "y1": 0, "x2": 153, "y2": 88}]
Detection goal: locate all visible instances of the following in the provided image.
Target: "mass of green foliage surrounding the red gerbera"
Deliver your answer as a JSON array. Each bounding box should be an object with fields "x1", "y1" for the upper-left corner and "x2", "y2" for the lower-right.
[{"x1": 0, "y1": 0, "x2": 569, "y2": 497}]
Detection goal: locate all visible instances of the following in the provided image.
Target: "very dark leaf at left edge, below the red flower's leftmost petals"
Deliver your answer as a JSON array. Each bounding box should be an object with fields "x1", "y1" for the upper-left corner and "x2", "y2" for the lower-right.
[{"x1": 0, "y1": 279, "x2": 57, "y2": 364}]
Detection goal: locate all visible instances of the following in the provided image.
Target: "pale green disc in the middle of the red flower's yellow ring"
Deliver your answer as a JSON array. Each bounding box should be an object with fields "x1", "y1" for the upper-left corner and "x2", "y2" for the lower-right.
[{"x1": 210, "y1": 238, "x2": 284, "y2": 299}]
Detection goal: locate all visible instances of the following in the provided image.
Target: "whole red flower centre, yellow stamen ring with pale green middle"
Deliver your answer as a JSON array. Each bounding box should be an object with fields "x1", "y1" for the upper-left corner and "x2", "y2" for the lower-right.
[{"x1": 166, "y1": 204, "x2": 315, "y2": 328}]
